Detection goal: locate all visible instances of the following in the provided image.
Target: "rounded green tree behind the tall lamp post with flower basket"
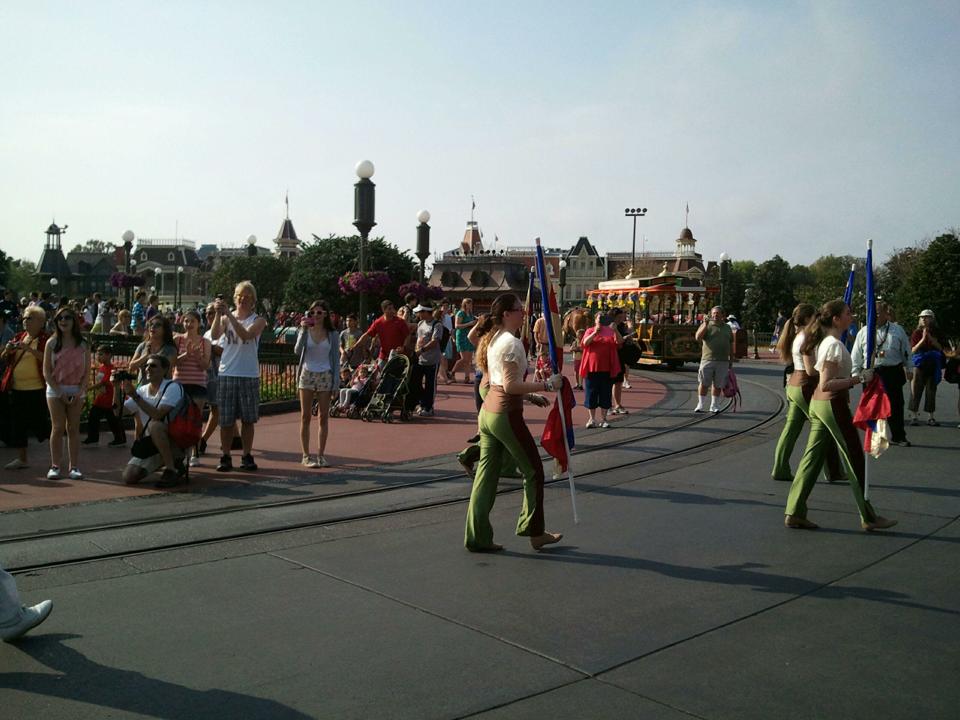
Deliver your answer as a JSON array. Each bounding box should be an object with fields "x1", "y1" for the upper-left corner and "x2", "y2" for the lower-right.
[{"x1": 284, "y1": 235, "x2": 415, "y2": 314}]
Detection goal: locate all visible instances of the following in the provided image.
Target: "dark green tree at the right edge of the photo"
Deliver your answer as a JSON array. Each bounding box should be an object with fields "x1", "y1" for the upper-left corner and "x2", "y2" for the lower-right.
[{"x1": 895, "y1": 230, "x2": 960, "y2": 338}]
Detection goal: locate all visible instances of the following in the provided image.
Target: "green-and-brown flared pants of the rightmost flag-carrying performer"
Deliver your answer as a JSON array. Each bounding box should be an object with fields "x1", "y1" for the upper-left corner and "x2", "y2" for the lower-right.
[{"x1": 785, "y1": 396, "x2": 877, "y2": 522}]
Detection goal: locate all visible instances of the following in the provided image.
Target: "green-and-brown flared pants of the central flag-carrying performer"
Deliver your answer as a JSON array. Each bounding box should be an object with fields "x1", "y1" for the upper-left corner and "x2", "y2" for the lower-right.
[{"x1": 463, "y1": 410, "x2": 544, "y2": 550}]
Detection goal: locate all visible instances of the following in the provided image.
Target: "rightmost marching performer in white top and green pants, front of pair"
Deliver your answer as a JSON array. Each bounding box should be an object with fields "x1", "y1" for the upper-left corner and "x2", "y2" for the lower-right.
[{"x1": 784, "y1": 300, "x2": 897, "y2": 531}]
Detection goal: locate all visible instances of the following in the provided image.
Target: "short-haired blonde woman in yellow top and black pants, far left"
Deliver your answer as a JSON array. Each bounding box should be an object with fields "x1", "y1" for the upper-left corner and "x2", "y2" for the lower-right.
[{"x1": 0, "y1": 305, "x2": 50, "y2": 470}]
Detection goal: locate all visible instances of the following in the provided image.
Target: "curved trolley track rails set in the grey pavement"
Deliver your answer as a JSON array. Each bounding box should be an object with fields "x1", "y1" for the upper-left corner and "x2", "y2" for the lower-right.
[{"x1": 7, "y1": 376, "x2": 784, "y2": 573}]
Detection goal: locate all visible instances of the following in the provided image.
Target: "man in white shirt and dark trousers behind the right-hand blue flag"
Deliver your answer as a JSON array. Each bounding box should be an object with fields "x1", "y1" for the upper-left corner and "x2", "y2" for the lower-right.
[{"x1": 850, "y1": 302, "x2": 910, "y2": 447}]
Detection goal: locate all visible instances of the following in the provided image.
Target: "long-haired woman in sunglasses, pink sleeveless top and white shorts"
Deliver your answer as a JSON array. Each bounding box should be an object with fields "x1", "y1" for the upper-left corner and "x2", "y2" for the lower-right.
[{"x1": 43, "y1": 308, "x2": 90, "y2": 480}]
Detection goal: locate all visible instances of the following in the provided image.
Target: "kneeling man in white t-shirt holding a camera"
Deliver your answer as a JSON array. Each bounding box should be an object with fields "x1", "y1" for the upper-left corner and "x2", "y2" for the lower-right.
[{"x1": 123, "y1": 354, "x2": 186, "y2": 488}]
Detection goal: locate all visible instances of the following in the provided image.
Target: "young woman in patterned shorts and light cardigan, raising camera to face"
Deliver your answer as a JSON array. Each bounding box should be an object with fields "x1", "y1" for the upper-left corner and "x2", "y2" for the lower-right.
[{"x1": 293, "y1": 300, "x2": 340, "y2": 468}]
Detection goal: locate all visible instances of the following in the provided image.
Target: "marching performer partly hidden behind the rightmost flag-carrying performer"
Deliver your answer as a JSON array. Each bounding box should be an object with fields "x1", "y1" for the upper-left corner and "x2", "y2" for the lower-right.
[{"x1": 771, "y1": 303, "x2": 844, "y2": 482}]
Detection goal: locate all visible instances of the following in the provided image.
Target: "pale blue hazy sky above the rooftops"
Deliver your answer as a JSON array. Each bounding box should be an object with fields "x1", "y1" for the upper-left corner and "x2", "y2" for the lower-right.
[{"x1": 0, "y1": 0, "x2": 960, "y2": 264}]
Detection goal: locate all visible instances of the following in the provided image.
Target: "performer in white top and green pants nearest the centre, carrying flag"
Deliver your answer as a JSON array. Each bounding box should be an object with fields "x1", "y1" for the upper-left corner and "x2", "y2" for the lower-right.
[{"x1": 464, "y1": 295, "x2": 562, "y2": 552}]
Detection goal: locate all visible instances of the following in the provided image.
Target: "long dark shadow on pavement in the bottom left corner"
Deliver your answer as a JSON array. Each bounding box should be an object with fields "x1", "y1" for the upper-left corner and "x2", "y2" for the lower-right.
[{"x1": 0, "y1": 634, "x2": 309, "y2": 720}]
